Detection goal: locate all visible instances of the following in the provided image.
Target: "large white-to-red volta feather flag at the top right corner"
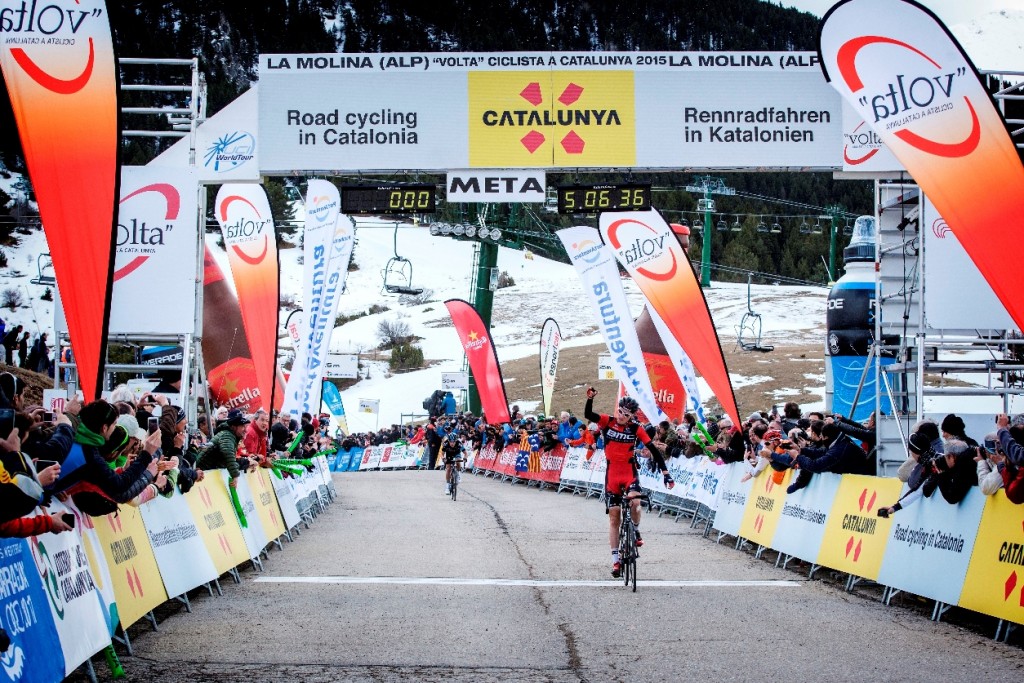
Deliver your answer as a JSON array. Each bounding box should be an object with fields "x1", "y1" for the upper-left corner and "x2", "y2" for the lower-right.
[{"x1": 820, "y1": 0, "x2": 1024, "y2": 328}]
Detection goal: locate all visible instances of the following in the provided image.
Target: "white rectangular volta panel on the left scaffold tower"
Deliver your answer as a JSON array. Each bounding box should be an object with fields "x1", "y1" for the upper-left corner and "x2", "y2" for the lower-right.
[{"x1": 110, "y1": 166, "x2": 199, "y2": 335}]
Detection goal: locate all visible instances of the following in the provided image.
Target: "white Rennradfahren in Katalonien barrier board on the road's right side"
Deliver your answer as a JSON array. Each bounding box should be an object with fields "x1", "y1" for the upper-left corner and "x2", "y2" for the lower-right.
[{"x1": 771, "y1": 472, "x2": 842, "y2": 562}]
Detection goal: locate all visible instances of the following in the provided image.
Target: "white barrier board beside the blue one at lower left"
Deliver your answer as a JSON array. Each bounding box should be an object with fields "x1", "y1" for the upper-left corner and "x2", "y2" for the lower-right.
[{"x1": 28, "y1": 501, "x2": 111, "y2": 676}]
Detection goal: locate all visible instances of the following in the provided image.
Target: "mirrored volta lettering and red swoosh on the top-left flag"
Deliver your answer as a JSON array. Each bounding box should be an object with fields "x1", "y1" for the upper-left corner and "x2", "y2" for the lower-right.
[{"x1": 0, "y1": 0, "x2": 103, "y2": 95}]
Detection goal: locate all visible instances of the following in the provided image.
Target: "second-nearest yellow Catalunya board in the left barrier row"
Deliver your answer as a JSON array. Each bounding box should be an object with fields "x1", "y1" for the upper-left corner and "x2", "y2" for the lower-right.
[{"x1": 185, "y1": 474, "x2": 249, "y2": 574}]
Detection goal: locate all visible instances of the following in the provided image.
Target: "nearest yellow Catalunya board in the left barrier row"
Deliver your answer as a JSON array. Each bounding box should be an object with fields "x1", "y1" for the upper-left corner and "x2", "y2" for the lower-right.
[{"x1": 94, "y1": 505, "x2": 167, "y2": 630}]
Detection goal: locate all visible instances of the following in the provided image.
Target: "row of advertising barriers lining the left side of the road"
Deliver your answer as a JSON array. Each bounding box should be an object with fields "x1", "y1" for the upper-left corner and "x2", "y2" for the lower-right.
[{"x1": 0, "y1": 456, "x2": 337, "y2": 683}]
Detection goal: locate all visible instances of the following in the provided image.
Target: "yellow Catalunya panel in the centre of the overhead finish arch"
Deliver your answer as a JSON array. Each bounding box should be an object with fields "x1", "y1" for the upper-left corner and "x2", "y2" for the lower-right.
[{"x1": 468, "y1": 71, "x2": 636, "y2": 168}]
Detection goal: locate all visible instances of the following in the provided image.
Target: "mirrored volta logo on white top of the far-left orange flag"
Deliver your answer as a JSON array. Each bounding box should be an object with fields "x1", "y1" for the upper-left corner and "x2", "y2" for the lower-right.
[{"x1": 0, "y1": 0, "x2": 106, "y2": 95}]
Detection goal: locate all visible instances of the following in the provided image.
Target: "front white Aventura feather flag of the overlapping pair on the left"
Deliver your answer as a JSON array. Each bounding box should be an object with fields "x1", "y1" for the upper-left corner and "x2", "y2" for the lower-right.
[{"x1": 284, "y1": 178, "x2": 341, "y2": 415}]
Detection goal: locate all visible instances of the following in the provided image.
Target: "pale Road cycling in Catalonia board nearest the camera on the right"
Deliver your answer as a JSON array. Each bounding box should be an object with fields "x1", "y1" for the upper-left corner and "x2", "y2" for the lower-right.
[{"x1": 876, "y1": 485, "x2": 987, "y2": 604}]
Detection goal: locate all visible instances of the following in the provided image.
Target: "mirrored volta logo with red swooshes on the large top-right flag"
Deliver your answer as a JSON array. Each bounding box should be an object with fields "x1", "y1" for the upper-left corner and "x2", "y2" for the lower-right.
[{"x1": 836, "y1": 36, "x2": 981, "y2": 158}]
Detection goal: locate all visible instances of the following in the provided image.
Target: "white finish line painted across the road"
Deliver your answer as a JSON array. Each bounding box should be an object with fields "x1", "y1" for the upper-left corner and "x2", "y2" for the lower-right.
[{"x1": 255, "y1": 577, "x2": 802, "y2": 588}]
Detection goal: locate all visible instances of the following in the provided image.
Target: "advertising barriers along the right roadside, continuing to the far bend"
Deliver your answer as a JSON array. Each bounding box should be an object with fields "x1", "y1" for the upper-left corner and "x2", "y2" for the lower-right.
[{"x1": 331, "y1": 443, "x2": 1024, "y2": 642}]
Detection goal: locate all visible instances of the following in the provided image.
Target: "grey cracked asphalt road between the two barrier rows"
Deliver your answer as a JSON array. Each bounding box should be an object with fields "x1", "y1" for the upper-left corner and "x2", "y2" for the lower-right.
[{"x1": 83, "y1": 471, "x2": 1024, "y2": 683}]
